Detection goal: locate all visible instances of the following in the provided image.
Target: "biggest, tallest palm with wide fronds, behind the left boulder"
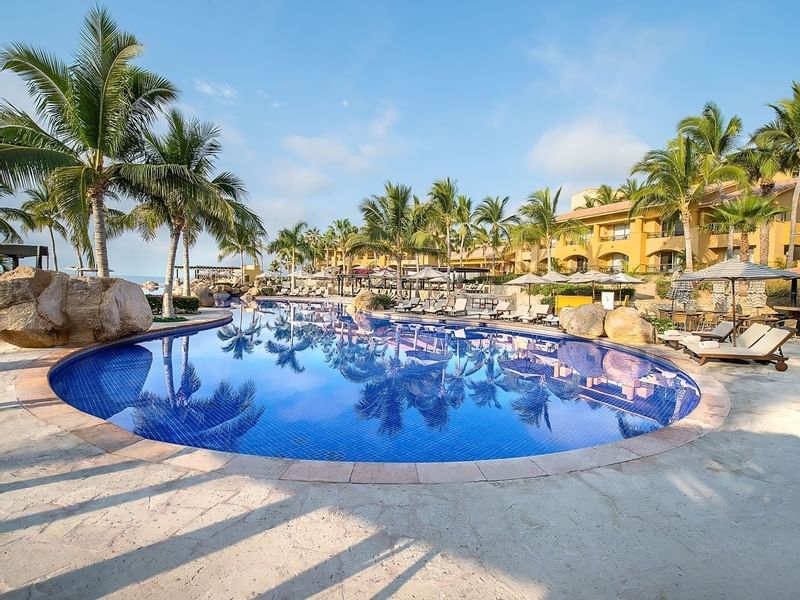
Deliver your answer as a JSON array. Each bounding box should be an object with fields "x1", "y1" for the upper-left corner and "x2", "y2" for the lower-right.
[{"x1": 0, "y1": 7, "x2": 176, "y2": 277}]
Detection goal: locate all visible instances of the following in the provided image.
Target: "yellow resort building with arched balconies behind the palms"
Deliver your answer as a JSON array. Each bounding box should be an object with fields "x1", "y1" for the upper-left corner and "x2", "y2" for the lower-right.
[{"x1": 460, "y1": 178, "x2": 800, "y2": 274}]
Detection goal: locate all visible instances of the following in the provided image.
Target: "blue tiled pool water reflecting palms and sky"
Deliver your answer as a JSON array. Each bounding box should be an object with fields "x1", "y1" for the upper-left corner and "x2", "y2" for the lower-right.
[{"x1": 51, "y1": 303, "x2": 699, "y2": 462}]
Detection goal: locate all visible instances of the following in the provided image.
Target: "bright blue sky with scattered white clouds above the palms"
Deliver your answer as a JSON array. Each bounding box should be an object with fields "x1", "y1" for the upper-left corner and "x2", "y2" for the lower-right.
[{"x1": 0, "y1": 0, "x2": 800, "y2": 274}]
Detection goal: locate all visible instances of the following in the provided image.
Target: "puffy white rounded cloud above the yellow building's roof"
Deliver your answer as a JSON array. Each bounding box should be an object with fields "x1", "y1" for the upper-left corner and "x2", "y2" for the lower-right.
[{"x1": 528, "y1": 117, "x2": 648, "y2": 184}]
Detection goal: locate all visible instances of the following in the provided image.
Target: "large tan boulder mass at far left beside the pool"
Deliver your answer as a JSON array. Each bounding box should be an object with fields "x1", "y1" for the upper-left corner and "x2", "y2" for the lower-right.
[{"x1": 0, "y1": 267, "x2": 153, "y2": 348}]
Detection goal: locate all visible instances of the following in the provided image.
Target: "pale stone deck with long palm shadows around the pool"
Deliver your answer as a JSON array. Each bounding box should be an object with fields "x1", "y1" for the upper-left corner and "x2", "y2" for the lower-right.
[{"x1": 0, "y1": 312, "x2": 800, "y2": 599}]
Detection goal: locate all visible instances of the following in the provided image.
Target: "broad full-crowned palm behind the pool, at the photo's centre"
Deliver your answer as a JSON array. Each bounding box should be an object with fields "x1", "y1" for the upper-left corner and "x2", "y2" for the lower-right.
[{"x1": 352, "y1": 181, "x2": 426, "y2": 295}]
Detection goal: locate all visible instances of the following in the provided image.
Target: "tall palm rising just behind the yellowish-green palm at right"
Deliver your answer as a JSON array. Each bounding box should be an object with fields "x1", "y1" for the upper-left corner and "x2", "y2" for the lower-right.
[{"x1": 678, "y1": 102, "x2": 744, "y2": 258}]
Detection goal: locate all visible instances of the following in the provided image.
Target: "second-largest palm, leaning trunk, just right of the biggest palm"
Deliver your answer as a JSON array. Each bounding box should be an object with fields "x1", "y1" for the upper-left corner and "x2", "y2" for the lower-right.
[{"x1": 126, "y1": 110, "x2": 256, "y2": 318}]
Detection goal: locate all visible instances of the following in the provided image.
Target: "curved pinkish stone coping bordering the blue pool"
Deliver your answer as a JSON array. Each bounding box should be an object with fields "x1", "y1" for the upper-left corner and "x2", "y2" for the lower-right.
[{"x1": 14, "y1": 312, "x2": 730, "y2": 484}]
